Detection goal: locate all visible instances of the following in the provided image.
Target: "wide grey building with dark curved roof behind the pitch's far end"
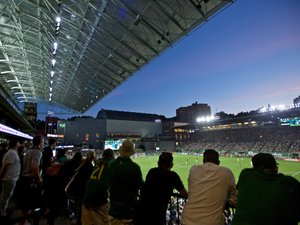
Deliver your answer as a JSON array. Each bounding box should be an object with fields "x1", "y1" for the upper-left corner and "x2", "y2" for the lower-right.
[{"x1": 57, "y1": 109, "x2": 165, "y2": 150}]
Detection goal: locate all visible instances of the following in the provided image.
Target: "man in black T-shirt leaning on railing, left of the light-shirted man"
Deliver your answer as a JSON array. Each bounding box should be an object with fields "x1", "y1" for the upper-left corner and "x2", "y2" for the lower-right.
[{"x1": 134, "y1": 152, "x2": 187, "y2": 225}]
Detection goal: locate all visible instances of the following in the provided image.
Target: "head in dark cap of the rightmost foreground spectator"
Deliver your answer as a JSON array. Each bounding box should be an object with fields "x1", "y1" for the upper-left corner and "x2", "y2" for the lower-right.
[{"x1": 252, "y1": 153, "x2": 278, "y2": 174}]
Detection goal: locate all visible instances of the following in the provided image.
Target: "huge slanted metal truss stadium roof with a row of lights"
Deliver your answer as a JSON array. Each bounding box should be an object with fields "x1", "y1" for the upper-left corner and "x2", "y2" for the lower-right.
[{"x1": 0, "y1": 0, "x2": 234, "y2": 112}]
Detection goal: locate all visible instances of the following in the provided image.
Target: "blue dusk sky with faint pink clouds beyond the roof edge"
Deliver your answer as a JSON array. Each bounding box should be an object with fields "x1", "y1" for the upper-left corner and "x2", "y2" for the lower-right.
[{"x1": 39, "y1": 0, "x2": 300, "y2": 117}]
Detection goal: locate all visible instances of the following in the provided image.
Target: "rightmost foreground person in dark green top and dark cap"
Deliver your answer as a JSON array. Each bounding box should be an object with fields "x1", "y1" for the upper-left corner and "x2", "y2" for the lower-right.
[{"x1": 232, "y1": 153, "x2": 300, "y2": 225}]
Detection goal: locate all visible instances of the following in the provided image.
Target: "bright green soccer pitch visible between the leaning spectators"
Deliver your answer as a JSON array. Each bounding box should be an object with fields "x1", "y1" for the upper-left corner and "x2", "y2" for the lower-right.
[{"x1": 134, "y1": 154, "x2": 300, "y2": 188}]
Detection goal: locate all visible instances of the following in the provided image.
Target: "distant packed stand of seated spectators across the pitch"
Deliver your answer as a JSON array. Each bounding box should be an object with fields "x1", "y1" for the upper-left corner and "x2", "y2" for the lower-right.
[{"x1": 180, "y1": 127, "x2": 300, "y2": 154}]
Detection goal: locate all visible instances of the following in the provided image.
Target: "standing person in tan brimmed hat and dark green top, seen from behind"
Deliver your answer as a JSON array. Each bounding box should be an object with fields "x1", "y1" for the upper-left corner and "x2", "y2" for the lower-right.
[{"x1": 109, "y1": 139, "x2": 143, "y2": 225}]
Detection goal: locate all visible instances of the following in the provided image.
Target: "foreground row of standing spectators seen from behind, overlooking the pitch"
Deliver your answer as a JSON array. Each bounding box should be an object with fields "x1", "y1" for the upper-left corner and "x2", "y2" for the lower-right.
[{"x1": 0, "y1": 136, "x2": 300, "y2": 225}]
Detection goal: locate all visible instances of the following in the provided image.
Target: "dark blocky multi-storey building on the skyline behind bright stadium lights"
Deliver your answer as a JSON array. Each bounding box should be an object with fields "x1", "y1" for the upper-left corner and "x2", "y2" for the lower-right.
[{"x1": 176, "y1": 102, "x2": 211, "y2": 124}]
